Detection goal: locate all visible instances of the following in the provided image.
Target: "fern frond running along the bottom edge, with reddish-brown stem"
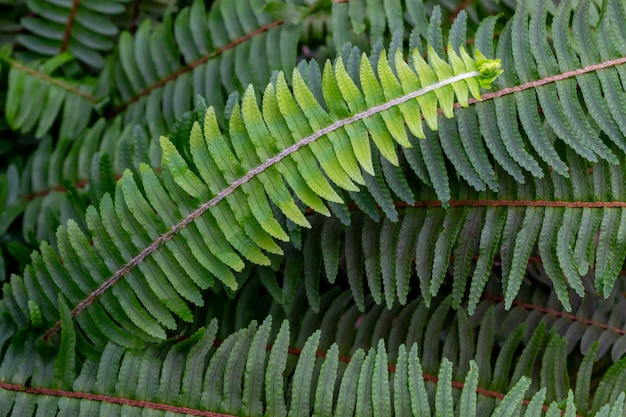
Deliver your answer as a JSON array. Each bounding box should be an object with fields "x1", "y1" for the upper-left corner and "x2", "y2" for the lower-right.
[{"x1": 0, "y1": 299, "x2": 624, "y2": 417}]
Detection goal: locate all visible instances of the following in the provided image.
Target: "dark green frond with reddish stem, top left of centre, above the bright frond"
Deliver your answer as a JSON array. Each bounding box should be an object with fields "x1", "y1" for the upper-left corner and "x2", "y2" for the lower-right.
[{"x1": 109, "y1": 0, "x2": 310, "y2": 137}]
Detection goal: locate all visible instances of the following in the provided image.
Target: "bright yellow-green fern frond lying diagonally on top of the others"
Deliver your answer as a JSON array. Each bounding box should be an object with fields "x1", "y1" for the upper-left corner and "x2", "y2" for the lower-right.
[{"x1": 1, "y1": 39, "x2": 498, "y2": 345}]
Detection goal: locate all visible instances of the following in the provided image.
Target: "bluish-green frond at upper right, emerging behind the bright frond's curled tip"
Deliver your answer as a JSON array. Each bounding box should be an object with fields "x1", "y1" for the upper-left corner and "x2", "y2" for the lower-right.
[{"x1": 326, "y1": 1, "x2": 626, "y2": 201}]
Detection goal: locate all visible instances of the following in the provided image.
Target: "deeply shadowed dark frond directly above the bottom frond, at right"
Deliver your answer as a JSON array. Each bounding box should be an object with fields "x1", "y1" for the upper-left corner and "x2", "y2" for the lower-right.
[{"x1": 200, "y1": 275, "x2": 626, "y2": 413}]
